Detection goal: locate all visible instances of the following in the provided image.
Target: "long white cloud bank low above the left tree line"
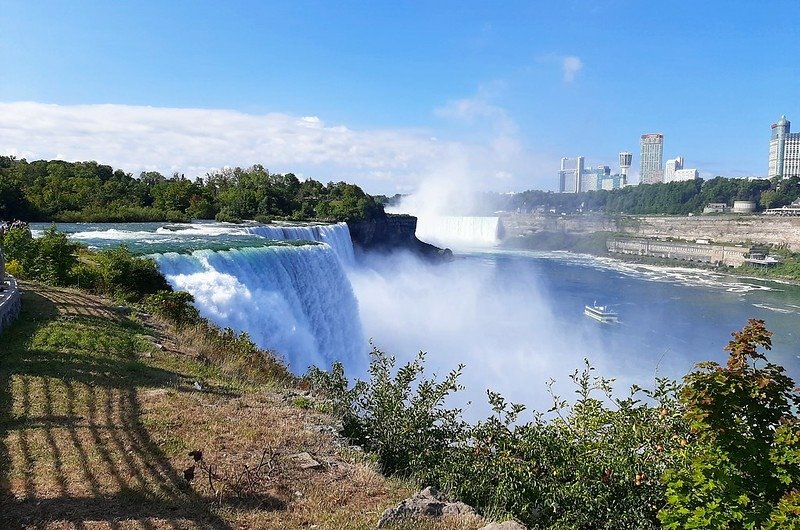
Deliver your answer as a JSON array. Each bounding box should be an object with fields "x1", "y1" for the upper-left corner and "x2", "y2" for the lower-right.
[{"x1": 0, "y1": 99, "x2": 556, "y2": 193}]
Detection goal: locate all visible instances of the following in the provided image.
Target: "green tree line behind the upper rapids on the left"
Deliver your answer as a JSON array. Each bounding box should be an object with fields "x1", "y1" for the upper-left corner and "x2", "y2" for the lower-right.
[{"x1": 0, "y1": 156, "x2": 384, "y2": 222}]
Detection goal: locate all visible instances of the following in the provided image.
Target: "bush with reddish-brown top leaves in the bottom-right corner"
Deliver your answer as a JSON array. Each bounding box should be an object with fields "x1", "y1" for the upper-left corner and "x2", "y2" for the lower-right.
[{"x1": 659, "y1": 320, "x2": 800, "y2": 529}]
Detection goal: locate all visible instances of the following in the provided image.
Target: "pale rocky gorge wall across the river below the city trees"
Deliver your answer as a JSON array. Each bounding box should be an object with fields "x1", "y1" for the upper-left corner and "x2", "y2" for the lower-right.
[{"x1": 502, "y1": 214, "x2": 800, "y2": 252}]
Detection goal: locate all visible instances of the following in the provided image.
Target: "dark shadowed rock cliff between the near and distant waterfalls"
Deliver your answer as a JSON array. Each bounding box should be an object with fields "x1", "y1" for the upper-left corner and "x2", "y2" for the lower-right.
[{"x1": 347, "y1": 214, "x2": 453, "y2": 261}]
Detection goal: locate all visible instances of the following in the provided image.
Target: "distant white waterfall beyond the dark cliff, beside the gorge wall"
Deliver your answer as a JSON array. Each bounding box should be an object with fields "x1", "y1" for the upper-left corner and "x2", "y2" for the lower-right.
[{"x1": 416, "y1": 216, "x2": 502, "y2": 247}]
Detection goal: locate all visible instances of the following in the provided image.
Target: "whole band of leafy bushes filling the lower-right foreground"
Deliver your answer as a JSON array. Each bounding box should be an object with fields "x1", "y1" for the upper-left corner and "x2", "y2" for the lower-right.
[{"x1": 307, "y1": 320, "x2": 800, "y2": 530}]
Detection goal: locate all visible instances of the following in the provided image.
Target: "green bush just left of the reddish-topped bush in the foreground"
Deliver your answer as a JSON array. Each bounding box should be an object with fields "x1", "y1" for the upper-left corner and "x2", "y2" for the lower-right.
[{"x1": 435, "y1": 362, "x2": 681, "y2": 529}]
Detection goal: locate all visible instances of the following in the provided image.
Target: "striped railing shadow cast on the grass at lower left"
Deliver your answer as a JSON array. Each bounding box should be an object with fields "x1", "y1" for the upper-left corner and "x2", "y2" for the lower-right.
[{"x1": 0, "y1": 288, "x2": 283, "y2": 529}]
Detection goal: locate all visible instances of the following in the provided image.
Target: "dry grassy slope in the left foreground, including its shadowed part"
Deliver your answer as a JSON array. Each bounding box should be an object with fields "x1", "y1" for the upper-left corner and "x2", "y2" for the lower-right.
[{"x1": 0, "y1": 284, "x2": 481, "y2": 529}]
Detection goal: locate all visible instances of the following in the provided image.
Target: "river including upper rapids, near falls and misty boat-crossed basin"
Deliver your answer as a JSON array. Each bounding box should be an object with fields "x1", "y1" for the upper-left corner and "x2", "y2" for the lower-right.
[{"x1": 32, "y1": 223, "x2": 800, "y2": 414}]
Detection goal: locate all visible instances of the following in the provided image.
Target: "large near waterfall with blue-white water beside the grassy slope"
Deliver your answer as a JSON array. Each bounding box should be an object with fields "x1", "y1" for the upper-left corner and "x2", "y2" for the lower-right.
[{"x1": 153, "y1": 242, "x2": 366, "y2": 374}]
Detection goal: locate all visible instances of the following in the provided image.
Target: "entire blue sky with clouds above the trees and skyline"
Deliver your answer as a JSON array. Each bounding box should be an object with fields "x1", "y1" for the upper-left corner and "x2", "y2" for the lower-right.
[{"x1": 0, "y1": 0, "x2": 800, "y2": 195}]
